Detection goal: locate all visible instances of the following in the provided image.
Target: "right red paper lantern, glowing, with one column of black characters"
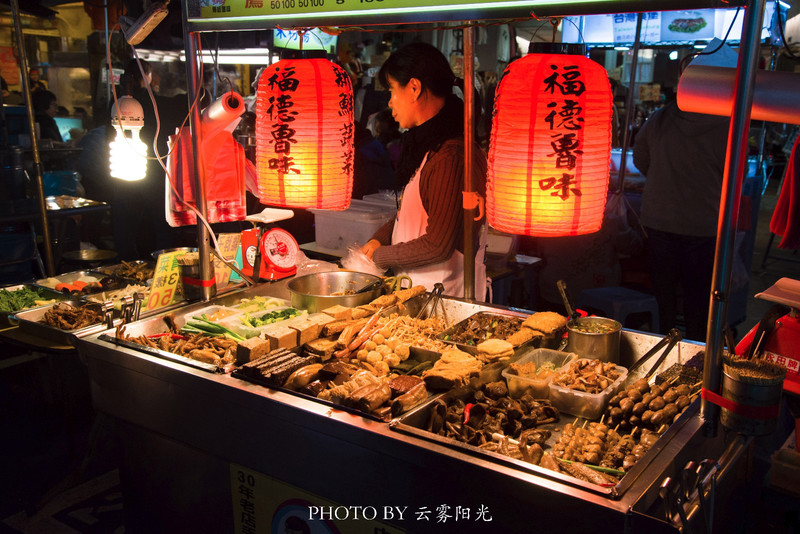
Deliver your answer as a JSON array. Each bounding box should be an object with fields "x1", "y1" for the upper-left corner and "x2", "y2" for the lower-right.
[{"x1": 486, "y1": 54, "x2": 612, "y2": 237}]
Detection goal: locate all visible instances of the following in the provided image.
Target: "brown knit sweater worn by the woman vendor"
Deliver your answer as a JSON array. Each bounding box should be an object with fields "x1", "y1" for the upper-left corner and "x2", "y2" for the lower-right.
[{"x1": 372, "y1": 139, "x2": 486, "y2": 270}]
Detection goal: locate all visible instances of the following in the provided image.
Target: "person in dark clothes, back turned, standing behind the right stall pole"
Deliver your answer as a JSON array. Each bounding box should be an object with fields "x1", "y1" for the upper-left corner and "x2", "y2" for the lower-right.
[{"x1": 633, "y1": 101, "x2": 729, "y2": 341}]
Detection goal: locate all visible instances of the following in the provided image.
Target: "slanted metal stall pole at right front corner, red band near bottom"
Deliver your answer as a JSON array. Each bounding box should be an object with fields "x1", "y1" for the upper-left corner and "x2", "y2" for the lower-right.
[{"x1": 701, "y1": 0, "x2": 765, "y2": 436}]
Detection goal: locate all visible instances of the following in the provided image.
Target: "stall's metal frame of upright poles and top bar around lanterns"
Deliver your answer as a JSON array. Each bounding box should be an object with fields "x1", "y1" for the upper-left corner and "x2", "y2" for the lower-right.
[{"x1": 182, "y1": 0, "x2": 765, "y2": 435}]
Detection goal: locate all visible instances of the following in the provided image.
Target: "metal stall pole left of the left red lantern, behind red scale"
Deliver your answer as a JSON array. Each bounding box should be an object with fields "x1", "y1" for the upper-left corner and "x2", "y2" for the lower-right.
[{"x1": 182, "y1": 12, "x2": 211, "y2": 301}]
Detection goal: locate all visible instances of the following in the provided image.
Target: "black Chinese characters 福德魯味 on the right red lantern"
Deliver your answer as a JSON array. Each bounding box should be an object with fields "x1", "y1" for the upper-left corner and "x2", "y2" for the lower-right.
[{"x1": 539, "y1": 65, "x2": 586, "y2": 201}]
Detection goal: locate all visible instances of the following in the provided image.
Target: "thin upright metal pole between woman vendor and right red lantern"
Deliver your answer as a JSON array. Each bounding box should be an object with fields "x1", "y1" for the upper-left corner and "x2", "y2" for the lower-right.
[{"x1": 463, "y1": 25, "x2": 475, "y2": 299}]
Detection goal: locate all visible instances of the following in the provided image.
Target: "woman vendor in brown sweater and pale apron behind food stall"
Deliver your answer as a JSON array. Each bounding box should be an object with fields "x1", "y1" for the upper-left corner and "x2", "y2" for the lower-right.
[{"x1": 362, "y1": 42, "x2": 487, "y2": 300}]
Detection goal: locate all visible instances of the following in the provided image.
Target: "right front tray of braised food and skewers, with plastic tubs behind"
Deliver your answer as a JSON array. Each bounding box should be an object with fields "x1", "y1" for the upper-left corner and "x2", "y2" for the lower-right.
[{"x1": 390, "y1": 348, "x2": 700, "y2": 498}]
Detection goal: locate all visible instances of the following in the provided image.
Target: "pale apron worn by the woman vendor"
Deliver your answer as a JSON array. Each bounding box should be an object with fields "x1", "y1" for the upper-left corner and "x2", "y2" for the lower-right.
[{"x1": 392, "y1": 154, "x2": 488, "y2": 301}]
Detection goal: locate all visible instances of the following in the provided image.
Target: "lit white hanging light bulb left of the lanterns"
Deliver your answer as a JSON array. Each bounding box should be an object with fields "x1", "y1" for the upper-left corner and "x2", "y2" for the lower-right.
[{"x1": 108, "y1": 96, "x2": 147, "y2": 182}]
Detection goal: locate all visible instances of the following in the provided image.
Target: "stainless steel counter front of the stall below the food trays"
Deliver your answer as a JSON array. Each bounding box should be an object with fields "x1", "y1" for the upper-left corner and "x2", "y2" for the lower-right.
[{"x1": 78, "y1": 285, "x2": 751, "y2": 533}]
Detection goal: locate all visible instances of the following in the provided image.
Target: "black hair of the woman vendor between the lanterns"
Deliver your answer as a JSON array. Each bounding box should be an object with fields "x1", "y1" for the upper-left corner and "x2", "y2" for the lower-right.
[{"x1": 378, "y1": 42, "x2": 456, "y2": 98}]
